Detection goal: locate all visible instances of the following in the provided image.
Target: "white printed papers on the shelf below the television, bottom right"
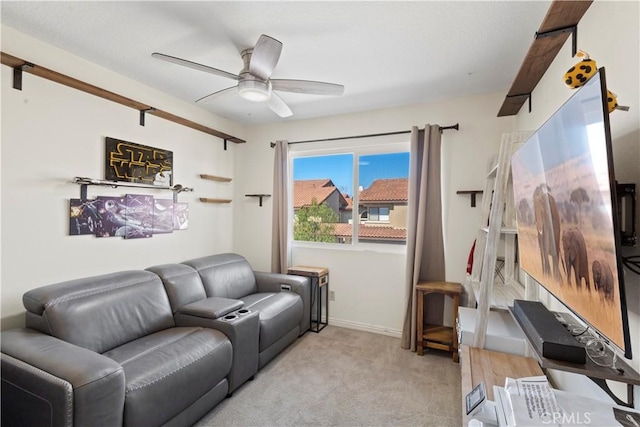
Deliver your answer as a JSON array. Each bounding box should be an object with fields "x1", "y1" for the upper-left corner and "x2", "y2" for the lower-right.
[{"x1": 494, "y1": 376, "x2": 640, "y2": 427}]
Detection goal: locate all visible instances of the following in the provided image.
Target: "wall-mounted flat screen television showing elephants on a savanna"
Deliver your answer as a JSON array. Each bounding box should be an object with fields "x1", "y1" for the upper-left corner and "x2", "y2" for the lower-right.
[{"x1": 511, "y1": 68, "x2": 631, "y2": 358}]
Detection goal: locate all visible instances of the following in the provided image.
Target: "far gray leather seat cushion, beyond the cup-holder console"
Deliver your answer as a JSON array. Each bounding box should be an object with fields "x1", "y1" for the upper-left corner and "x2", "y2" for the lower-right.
[{"x1": 241, "y1": 292, "x2": 303, "y2": 352}]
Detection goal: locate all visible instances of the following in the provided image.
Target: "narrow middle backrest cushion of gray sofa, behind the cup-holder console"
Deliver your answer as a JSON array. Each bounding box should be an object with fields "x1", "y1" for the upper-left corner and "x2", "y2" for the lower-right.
[{"x1": 147, "y1": 264, "x2": 207, "y2": 314}]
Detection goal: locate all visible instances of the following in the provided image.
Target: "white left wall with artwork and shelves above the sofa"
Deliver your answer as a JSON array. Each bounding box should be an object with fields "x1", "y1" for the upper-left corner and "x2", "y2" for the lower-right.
[{"x1": 0, "y1": 27, "x2": 243, "y2": 329}]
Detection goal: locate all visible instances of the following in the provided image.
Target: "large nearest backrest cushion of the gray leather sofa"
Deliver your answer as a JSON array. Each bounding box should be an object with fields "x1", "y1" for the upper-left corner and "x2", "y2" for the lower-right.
[{"x1": 23, "y1": 271, "x2": 175, "y2": 353}]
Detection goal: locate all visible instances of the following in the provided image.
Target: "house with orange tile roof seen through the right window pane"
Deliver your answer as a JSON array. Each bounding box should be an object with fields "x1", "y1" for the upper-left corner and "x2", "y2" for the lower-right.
[{"x1": 359, "y1": 178, "x2": 409, "y2": 229}]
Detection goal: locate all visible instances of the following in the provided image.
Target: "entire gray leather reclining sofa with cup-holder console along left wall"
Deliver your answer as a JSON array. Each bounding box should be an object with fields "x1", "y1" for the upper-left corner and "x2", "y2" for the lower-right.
[{"x1": 0, "y1": 254, "x2": 310, "y2": 426}]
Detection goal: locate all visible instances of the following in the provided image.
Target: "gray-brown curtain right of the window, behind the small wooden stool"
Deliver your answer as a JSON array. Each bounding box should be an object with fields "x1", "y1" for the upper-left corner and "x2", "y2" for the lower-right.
[{"x1": 401, "y1": 125, "x2": 445, "y2": 351}]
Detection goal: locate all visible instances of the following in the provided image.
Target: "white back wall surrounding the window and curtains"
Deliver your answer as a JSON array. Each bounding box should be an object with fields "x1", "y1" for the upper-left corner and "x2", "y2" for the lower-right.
[{"x1": 234, "y1": 92, "x2": 513, "y2": 336}]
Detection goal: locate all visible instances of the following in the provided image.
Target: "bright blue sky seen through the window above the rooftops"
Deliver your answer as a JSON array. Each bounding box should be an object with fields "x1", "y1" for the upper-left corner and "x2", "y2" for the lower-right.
[{"x1": 293, "y1": 153, "x2": 409, "y2": 196}]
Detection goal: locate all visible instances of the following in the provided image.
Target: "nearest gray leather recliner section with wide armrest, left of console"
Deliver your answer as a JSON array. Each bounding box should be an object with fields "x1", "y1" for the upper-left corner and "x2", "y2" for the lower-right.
[{"x1": 1, "y1": 271, "x2": 232, "y2": 426}]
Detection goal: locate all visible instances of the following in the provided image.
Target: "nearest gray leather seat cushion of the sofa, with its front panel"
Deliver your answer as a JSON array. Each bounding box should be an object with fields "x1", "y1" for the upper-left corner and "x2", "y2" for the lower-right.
[{"x1": 104, "y1": 327, "x2": 232, "y2": 426}]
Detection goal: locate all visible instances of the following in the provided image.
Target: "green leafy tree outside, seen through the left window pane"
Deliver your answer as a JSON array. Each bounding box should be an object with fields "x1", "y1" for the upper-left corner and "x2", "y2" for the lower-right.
[{"x1": 293, "y1": 199, "x2": 339, "y2": 243}]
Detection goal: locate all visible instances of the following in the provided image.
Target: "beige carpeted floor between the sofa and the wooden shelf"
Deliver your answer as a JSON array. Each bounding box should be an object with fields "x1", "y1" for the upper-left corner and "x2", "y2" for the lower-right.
[{"x1": 196, "y1": 326, "x2": 462, "y2": 427}]
